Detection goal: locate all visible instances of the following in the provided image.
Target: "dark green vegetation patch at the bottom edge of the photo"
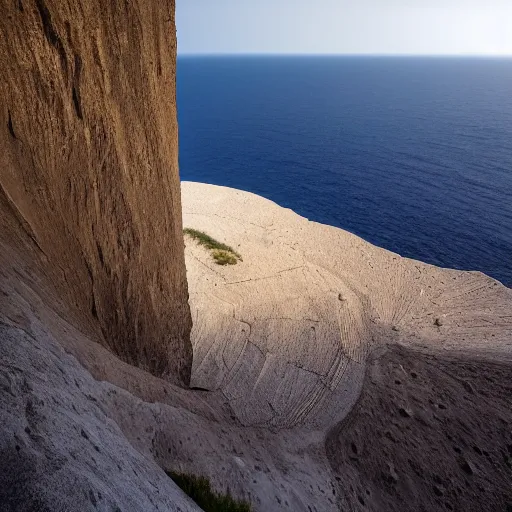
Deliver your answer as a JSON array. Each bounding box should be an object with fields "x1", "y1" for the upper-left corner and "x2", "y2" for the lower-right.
[{"x1": 167, "y1": 471, "x2": 252, "y2": 512}]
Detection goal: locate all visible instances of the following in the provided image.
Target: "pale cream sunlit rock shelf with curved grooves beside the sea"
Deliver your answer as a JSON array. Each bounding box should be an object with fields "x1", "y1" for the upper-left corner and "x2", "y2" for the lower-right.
[{"x1": 182, "y1": 183, "x2": 512, "y2": 431}]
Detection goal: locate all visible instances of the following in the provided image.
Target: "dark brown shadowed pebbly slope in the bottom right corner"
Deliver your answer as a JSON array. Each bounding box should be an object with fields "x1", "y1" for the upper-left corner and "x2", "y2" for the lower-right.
[{"x1": 326, "y1": 347, "x2": 512, "y2": 512}]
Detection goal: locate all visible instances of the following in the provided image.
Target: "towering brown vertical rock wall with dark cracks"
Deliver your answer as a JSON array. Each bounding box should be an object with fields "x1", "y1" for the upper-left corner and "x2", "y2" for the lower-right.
[{"x1": 0, "y1": 0, "x2": 192, "y2": 384}]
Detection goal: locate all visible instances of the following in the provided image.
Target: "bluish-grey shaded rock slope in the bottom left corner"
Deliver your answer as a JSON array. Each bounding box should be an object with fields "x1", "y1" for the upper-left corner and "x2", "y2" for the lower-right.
[{"x1": 0, "y1": 321, "x2": 200, "y2": 512}]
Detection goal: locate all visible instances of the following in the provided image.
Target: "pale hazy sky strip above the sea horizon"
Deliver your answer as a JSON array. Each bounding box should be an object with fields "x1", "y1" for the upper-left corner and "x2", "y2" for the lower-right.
[{"x1": 176, "y1": 0, "x2": 512, "y2": 55}]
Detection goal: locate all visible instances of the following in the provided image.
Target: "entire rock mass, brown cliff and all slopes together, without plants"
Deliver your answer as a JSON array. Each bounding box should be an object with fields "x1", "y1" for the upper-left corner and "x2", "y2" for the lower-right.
[{"x1": 0, "y1": 0, "x2": 512, "y2": 512}]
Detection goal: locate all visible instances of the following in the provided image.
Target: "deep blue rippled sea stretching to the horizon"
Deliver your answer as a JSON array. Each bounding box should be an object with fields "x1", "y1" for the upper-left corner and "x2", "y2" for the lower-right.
[{"x1": 178, "y1": 57, "x2": 512, "y2": 286}]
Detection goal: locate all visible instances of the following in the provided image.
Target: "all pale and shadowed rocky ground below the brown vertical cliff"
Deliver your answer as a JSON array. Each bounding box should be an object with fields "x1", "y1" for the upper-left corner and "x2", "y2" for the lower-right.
[{"x1": 0, "y1": 183, "x2": 512, "y2": 512}]
